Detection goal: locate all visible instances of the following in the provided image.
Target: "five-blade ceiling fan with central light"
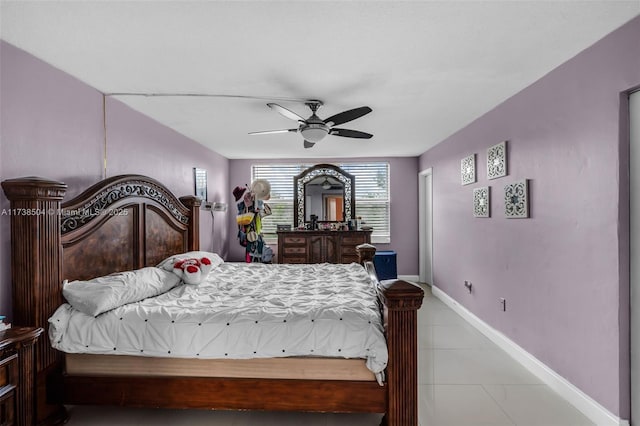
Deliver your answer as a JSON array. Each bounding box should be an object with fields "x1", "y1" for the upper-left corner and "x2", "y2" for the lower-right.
[{"x1": 249, "y1": 99, "x2": 373, "y2": 148}]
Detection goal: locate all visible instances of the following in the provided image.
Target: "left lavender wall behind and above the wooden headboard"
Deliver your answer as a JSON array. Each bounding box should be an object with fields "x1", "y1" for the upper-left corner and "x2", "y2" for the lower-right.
[{"x1": 0, "y1": 41, "x2": 230, "y2": 320}]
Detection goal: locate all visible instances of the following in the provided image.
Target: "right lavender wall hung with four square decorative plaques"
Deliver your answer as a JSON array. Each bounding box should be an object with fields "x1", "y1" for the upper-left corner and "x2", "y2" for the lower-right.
[{"x1": 419, "y1": 18, "x2": 640, "y2": 418}]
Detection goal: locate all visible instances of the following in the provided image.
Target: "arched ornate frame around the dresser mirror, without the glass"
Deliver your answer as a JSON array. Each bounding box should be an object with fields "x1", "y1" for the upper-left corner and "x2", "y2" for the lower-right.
[{"x1": 293, "y1": 164, "x2": 356, "y2": 228}]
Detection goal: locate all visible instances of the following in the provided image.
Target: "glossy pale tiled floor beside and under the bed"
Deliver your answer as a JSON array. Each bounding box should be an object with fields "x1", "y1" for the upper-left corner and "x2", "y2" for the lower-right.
[{"x1": 67, "y1": 284, "x2": 594, "y2": 426}]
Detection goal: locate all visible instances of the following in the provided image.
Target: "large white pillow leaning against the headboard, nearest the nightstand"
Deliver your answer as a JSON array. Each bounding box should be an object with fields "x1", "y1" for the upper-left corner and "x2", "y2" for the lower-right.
[{"x1": 62, "y1": 267, "x2": 180, "y2": 316}]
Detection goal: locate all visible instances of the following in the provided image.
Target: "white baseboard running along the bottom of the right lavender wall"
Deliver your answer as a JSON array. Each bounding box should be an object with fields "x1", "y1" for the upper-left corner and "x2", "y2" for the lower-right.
[{"x1": 431, "y1": 286, "x2": 629, "y2": 426}]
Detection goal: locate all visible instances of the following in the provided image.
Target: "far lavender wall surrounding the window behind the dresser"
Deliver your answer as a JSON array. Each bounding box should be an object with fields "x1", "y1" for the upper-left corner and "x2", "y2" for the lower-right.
[{"x1": 229, "y1": 157, "x2": 418, "y2": 275}]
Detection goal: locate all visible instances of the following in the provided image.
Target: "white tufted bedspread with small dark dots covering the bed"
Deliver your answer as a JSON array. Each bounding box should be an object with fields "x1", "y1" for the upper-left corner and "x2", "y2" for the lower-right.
[{"x1": 49, "y1": 263, "x2": 387, "y2": 377}]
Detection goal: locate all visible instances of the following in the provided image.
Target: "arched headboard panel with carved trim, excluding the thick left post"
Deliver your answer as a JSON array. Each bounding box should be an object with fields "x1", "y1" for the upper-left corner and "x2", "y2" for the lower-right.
[{"x1": 60, "y1": 175, "x2": 200, "y2": 280}]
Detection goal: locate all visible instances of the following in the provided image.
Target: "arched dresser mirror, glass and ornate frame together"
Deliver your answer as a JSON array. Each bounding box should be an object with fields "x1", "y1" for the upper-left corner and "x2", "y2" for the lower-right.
[{"x1": 293, "y1": 164, "x2": 356, "y2": 228}]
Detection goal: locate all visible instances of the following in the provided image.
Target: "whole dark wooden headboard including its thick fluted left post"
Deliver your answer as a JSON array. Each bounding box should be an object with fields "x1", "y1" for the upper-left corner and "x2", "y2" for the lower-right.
[{"x1": 2, "y1": 175, "x2": 201, "y2": 420}]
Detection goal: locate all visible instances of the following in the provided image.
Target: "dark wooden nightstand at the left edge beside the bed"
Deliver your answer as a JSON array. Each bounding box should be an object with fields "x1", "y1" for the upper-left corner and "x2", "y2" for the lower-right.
[{"x1": 0, "y1": 327, "x2": 43, "y2": 426}]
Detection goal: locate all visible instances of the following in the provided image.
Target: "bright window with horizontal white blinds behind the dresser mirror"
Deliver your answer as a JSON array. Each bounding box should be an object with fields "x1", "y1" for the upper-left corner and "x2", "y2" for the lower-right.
[{"x1": 251, "y1": 162, "x2": 391, "y2": 243}]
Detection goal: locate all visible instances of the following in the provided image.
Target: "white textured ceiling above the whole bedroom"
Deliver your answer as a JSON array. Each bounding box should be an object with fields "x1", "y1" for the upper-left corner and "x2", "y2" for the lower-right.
[{"x1": 0, "y1": 0, "x2": 640, "y2": 158}]
